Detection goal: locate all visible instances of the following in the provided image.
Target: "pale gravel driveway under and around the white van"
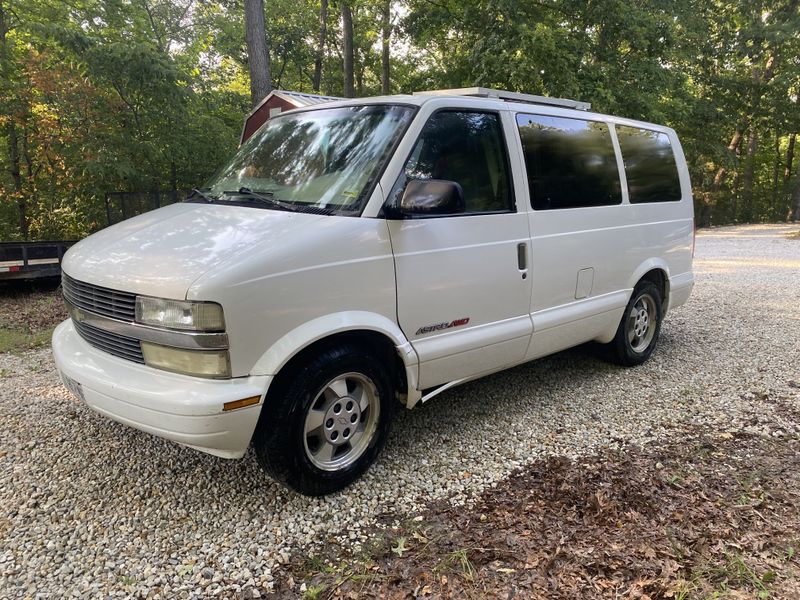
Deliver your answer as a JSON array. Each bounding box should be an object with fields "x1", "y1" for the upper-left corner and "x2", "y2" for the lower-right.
[{"x1": 0, "y1": 225, "x2": 800, "y2": 598}]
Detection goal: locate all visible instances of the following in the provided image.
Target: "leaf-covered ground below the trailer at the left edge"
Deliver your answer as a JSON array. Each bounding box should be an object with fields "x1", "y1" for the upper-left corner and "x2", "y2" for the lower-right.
[{"x1": 0, "y1": 282, "x2": 67, "y2": 334}]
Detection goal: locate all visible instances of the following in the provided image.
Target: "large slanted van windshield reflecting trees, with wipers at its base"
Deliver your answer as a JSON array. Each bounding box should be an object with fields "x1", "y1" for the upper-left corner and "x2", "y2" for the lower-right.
[{"x1": 203, "y1": 105, "x2": 414, "y2": 214}]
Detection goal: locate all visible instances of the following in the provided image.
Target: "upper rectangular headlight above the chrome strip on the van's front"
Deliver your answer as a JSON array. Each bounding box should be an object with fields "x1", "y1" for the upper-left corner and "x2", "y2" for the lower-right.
[{"x1": 136, "y1": 296, "x2": 225, "y2": 331}]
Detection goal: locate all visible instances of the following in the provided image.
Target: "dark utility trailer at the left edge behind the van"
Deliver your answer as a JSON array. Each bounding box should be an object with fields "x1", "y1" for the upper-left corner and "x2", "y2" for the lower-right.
[{"x1": 0, "y1": 240, "x2": 75, "y2": 281}]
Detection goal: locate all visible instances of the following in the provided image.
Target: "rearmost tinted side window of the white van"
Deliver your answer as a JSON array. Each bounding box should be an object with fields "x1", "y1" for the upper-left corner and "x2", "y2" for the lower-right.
[{"x1": 617, "y1": 125, "x2": 681, "y2": 204}]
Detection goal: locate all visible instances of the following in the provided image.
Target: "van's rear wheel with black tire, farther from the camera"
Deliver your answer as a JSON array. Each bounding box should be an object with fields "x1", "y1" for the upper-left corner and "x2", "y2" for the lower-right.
[{"x1": 607, "y1": 281, "x2": 662, "y2": 367}]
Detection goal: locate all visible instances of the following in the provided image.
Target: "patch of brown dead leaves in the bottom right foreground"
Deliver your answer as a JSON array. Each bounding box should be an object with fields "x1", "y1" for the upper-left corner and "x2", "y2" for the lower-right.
[{"x1": 286, "y1": 432, "x2": 800, "y2": 599}]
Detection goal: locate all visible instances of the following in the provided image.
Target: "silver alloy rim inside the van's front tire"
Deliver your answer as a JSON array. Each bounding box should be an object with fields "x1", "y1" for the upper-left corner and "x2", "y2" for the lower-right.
[{"x1": 303, "y1": 373, "x2": 380, "y2": 471}]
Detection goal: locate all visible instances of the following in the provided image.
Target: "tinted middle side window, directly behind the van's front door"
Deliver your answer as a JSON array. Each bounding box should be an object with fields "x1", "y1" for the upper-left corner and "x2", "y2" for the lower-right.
[{"x1": 517, "y1": 114, "x2": 622, "y2": 210}]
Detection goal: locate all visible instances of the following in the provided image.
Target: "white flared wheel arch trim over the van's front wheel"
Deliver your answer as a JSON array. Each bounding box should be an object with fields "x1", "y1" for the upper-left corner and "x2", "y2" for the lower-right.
[{"x1": 251, "y1": 311, "x2": 421, "y2": 408}]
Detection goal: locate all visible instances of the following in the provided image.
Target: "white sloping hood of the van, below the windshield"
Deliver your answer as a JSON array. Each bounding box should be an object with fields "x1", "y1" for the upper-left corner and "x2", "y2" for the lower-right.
[{"x1": 62, "y1": 203, "x2": 325, "y2": 299}]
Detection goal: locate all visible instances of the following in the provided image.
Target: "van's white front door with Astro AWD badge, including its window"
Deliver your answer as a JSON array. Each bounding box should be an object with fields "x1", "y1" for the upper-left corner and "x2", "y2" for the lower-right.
[{"x1": 389, "y1": 109, "x2": 532, "y2": 389}]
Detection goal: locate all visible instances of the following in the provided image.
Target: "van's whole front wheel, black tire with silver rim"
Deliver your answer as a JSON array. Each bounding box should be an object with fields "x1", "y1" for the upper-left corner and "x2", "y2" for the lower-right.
[{"x1": 253, "y1": 343, "x2": 397, "y2": 496}]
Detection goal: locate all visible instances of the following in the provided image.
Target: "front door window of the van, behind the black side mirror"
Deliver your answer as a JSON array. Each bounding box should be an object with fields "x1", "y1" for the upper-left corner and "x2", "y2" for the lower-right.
[{"x1": 401, "y1": 110, "x2": 514, "y2": 213}]
